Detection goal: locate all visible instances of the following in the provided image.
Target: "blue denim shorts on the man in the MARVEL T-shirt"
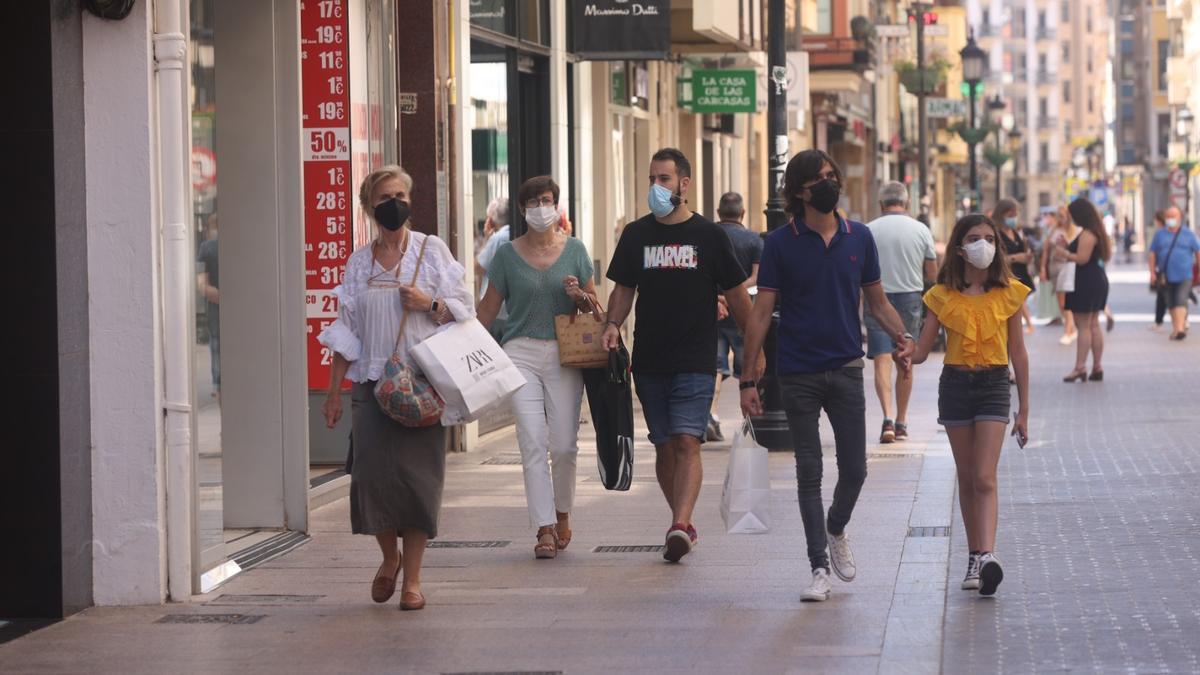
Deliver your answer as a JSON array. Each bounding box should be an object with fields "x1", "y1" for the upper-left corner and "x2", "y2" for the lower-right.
[{"x1": 634, "y1": 372, "x2": 716, "y2": 446}]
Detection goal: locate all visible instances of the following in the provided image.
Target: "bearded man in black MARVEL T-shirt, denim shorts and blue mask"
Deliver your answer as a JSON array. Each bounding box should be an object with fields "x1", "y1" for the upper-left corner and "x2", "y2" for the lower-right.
[{"x1": 604, "y1": 148, "x2": 750, "y2": 562}]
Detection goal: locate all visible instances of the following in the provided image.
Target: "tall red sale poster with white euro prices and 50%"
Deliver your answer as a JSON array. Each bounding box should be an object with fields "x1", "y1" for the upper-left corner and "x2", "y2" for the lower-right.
[{"x1": 300, "y1": 0, "x2": 354, "y2": 389}]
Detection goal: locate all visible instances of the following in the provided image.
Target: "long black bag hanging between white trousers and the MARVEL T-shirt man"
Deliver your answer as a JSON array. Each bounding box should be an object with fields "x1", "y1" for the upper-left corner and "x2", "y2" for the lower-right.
[{"x1": 583, "y1": 345, "x2": 634, "y2": 490}]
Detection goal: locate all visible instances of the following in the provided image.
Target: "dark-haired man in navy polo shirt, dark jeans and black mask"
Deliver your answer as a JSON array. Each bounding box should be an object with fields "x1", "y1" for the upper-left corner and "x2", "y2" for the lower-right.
[{"x1": 740, "y1": 150, "x2": 913, "y2": 602}]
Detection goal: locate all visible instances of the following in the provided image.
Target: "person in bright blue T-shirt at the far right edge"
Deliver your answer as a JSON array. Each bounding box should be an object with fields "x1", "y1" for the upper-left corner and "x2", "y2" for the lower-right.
[{"x1": 1150, "y1": 207, "x2": 1200, "y2": 340}]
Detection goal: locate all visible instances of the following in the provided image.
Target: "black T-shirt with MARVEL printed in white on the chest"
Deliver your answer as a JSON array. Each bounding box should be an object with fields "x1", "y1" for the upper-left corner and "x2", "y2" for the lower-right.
[{"x1": 608, "y1": 214, "x2": 746, "y2": 374}]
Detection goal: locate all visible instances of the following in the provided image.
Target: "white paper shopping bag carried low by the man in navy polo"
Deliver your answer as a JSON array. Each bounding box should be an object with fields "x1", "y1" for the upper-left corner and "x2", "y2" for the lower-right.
[{"x1": 721, "y1": 419, "x2": 770, "y2": 534}]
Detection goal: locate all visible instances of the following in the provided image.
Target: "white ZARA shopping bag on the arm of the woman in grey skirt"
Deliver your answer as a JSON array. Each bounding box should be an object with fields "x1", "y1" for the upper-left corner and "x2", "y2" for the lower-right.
[{"x1": 409, "y1": 318, "x2": 526, "y2": 426}]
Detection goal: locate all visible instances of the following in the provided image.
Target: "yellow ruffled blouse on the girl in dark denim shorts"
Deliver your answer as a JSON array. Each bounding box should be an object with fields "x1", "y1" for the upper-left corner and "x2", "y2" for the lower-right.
[{"x1": 925, "y1": 279, "x2": 1030, "y2": 368}]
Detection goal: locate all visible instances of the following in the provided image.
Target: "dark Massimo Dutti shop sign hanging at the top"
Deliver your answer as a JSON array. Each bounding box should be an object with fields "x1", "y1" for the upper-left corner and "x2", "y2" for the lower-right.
[{"x1": 570, "y1": 0, "x2": 671, "y2": 61}]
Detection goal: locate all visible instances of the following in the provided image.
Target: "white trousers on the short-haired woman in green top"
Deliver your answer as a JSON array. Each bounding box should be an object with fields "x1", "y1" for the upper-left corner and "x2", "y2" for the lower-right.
[{"x1": 504, "y1": 338, "x2": 583, "y2": 527}]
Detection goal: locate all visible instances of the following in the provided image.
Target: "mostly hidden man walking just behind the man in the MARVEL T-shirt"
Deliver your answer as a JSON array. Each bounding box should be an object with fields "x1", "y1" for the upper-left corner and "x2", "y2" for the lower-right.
[{"x1": 707, "y1": 192, "x2": 762, "y2": 442}]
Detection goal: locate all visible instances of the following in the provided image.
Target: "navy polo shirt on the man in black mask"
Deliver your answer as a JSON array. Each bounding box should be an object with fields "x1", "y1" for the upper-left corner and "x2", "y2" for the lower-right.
[{"x1": 758, "y1": 216, "x2": 880, "y2": 375}]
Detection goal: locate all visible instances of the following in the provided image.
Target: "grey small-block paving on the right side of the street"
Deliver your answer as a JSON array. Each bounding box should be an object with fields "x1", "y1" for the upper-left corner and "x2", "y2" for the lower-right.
[{"x1": 943, "y1": 265, "x2": 1200, "y2": 673}]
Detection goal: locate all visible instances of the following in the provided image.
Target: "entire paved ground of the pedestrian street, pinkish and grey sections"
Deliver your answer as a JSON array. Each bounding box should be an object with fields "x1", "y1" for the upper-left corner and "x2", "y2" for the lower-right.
[{"x1": 0, "y1": 260, "x2": 1200, "y2": 673}]
